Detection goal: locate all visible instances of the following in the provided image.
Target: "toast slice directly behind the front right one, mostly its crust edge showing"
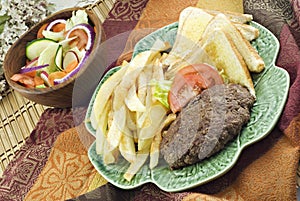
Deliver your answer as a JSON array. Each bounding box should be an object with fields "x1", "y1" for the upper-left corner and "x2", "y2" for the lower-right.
[{"x1": 204, "y1": 14, "x2": 265, "y2": 73}]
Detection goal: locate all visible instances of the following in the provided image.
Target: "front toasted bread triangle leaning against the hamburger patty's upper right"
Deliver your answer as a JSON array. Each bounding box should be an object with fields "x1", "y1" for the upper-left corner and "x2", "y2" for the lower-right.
[{"x1": 201, "y1": 28, "x2": 256, "y2": 97}]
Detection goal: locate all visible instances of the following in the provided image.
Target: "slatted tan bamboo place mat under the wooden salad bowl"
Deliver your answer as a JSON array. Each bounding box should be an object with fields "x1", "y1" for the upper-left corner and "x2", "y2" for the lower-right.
[{"x1": 0, "y1": 0, "x2": 115, "y2": 177}]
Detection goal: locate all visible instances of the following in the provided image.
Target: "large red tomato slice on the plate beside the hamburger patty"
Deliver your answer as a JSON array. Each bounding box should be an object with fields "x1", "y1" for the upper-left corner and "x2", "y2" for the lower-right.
[{"x1": 168, "y1": 64, "x2": 223, "y2": 113}]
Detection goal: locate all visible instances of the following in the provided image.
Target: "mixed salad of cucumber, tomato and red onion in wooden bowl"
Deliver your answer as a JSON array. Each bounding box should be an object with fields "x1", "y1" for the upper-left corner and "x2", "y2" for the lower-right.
[{"x1": 11, "y1": 10, "x2": 96, "y2": 88}]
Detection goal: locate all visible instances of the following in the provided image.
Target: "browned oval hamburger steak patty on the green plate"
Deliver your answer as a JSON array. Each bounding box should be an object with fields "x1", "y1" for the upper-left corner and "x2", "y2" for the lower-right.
[{"x1": 160, "y1": 84, "x2": 255, "y2": 169}]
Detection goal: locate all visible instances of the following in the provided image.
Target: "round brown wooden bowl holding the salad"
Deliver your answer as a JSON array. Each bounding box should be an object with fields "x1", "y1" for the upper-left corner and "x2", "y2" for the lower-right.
[{"x1": 3, "y1": 7, "x2": 104, "y2": 108}]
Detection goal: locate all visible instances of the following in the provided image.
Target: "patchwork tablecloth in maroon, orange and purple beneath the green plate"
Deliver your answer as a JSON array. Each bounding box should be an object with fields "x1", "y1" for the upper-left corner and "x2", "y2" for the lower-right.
[{"x1": 0, "y1": 0, "x2": 300, "y2": 201}]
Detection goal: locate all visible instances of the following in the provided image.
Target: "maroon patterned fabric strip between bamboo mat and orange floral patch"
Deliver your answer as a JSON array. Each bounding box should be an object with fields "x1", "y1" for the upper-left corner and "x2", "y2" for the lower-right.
[{"x1": 0, "y1": 109, "x2": 74, "y2": 201}]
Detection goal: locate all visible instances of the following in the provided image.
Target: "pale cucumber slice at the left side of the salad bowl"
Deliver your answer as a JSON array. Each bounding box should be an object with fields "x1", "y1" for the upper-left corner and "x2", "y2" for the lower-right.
[{"x1": 26, "y1": 38, "x2": 56, "y2": 60}]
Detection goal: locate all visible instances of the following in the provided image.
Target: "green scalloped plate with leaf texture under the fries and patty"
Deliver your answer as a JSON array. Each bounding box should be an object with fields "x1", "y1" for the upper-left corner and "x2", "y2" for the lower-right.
[{"x1": 85, "y1": 22, "x2": 290, "y2": 192}]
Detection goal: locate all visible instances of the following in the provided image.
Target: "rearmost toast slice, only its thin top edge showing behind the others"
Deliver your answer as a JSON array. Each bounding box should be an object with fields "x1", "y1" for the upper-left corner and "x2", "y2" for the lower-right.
[{"x1": 203, "y1": 9, "x2": 253, "y2": 24}]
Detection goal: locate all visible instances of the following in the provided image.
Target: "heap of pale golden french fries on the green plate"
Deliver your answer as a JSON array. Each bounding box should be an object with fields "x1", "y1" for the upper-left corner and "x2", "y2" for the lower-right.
[{"x1": 91, "y1": 41, "x2": 173, "y2": 181}]
